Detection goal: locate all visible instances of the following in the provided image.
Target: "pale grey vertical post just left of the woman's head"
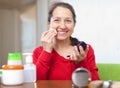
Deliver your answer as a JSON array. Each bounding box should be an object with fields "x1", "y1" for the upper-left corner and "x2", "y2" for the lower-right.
[{"x1": 36, "y1": 0, "x2": 48, "y2": 46}]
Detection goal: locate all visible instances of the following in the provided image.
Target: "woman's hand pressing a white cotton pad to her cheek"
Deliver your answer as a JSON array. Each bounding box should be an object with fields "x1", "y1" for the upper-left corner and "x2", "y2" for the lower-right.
[{"x1": 41, "y1": 29, "x2": 57, "y2": 52}]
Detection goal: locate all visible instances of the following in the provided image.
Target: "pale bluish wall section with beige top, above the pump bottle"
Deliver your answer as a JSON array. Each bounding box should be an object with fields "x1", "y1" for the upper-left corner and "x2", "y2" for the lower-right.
[{"x1": 20, "y1": 4, "x2": 36, "y2": 53}]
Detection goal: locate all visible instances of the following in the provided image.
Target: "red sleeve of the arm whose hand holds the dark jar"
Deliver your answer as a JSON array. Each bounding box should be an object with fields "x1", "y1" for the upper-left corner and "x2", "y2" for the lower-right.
[{"x1": 87, "y1": 45, "x2": 100, "y2": 80}]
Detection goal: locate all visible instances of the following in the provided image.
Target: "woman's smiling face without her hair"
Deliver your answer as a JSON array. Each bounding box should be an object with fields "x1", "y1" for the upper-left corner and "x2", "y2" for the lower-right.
[{"x1": 49, "y1": 7, "x2": 75, "y2": 40}]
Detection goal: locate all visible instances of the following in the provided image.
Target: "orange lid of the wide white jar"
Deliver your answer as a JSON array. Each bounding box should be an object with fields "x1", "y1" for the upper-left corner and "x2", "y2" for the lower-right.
[{"x1": 2, "y1": 65, "x2": 24, "y2": 70}]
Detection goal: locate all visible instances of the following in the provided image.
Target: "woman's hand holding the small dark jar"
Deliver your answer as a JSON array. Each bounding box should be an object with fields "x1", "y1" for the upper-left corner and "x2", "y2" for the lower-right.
[{"x1": 70, "y1": 45, "x2": 89, "y2": 64}]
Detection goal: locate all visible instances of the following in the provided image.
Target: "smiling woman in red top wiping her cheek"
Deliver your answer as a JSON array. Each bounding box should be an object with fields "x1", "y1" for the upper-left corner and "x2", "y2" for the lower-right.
[{"x1": 33, "y1": 2, "x2": 99, "y2": 80}]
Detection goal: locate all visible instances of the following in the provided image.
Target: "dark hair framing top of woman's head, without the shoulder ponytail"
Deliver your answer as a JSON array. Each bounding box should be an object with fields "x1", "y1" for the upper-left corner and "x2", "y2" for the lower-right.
[{"x1": 48, "y1": 2, "x2": 76, "y2": 23}]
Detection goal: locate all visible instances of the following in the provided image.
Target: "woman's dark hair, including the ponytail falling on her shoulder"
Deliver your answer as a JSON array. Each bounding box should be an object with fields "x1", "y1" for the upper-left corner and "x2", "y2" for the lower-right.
[{"x1": 48, "y1": 2, "x2": 79, "y2": 46}]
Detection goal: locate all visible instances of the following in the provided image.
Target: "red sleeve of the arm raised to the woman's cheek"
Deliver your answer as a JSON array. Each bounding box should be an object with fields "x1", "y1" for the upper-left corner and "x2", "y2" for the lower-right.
[{"x1": 33, "y1": 47, "x2": 52, "y2": 80}]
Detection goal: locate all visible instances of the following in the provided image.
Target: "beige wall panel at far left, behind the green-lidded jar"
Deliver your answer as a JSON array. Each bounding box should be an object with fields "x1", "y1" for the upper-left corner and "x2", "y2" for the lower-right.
[{"x1": 0, "y1": 9, "x2": 21, "y2": 68}]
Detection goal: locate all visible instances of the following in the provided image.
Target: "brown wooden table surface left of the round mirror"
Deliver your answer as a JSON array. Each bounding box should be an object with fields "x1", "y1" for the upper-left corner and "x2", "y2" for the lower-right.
[{"x1": 0, "y1": 80, "x2": 72, "y2": 88}]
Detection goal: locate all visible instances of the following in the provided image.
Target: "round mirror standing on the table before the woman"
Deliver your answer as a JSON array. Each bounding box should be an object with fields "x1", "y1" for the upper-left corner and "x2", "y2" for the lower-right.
[{"x1": 72, "y1": 68, "x2": 91, "y2": 88}]
